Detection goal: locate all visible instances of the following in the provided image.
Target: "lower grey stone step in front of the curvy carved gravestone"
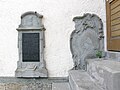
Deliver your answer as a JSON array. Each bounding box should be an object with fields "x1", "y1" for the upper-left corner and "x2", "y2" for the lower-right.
[{"x1": 69, "y1": 70, "x2": 102, "y2": 90}]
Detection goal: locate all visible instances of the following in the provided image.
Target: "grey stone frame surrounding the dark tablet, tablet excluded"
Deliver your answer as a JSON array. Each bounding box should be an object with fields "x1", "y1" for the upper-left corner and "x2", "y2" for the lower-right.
[{"x1": 15, "y1": 12, "x2": 48, "y2": 77}]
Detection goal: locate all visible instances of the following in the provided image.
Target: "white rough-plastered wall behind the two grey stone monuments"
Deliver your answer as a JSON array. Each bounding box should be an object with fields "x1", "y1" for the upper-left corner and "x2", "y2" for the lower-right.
[{"x1": 0, "y1": 0, "x2": 106, "y2": 77}]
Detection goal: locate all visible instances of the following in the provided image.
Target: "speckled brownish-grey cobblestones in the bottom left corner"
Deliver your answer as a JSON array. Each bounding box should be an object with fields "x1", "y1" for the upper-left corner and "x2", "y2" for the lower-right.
[{"x1": 0, "y1": 83, "x2": 52, "y2": 90}]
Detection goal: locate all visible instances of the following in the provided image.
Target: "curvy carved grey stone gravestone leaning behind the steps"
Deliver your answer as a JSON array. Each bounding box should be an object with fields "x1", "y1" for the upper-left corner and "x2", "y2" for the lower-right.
[{"x1": 70, "y1": 13, "x2": 104, "y2": 70}]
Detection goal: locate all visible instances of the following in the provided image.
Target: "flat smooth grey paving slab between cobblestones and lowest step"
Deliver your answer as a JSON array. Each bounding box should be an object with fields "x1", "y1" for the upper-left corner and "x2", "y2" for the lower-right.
[{"x1": 52, "y1": 83, "x2": 71, "y2": 90}]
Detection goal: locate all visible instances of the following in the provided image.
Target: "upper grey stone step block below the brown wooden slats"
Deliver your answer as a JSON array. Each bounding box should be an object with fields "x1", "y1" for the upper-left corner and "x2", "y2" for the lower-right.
[{"x1": 87, "y1": 59, "x2": 120, "y2": 90}]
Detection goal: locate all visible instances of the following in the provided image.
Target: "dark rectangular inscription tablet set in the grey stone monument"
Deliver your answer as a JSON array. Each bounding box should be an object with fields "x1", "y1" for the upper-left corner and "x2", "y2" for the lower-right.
[{"x1": 22, "y1": 33, "x2": 40, "y2": 62}]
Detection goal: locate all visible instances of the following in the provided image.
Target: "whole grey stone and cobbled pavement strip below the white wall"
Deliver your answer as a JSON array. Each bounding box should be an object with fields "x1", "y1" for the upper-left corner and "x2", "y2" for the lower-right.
[{"x1": 0, "y1": 77, "x2": 69, "y2": 90}]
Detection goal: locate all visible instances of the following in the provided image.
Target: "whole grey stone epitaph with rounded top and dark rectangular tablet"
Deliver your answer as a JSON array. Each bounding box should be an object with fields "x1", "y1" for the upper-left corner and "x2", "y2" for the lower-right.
[{"x1": 15, "y1": 12, "x2": 48, "y2": 77}]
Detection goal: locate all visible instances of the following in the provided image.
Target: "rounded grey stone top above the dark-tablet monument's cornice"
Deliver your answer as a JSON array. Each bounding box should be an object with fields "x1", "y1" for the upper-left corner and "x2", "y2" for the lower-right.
[{"x1": 17, "y1": 11, "x2": 44, "y2": 30}]
